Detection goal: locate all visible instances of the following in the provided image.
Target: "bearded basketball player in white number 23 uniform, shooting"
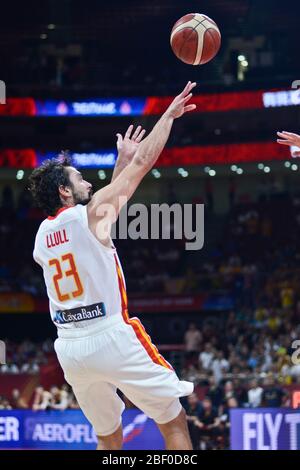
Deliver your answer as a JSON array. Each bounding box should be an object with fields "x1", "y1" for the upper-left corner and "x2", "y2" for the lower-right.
[{"x1": 29, "y1": 82, "x2": 196, "y2": 450}]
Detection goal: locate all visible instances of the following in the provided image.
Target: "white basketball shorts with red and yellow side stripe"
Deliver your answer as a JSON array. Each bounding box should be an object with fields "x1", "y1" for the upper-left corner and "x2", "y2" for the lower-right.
[{"x1": 54, "y1": 314, "x2": 194, "y2": 436}]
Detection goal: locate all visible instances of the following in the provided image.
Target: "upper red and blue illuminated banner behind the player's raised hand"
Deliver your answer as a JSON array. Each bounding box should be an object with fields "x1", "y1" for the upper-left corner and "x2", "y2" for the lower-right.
[{"x1": 0, "y1": 89, "x2": 300, "y2": 117}]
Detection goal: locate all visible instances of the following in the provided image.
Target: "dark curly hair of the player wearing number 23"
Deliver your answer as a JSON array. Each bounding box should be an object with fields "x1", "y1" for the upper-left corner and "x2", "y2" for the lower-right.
[{"x1": 28, "y1": 151, "x2": 72, "y2": 216}]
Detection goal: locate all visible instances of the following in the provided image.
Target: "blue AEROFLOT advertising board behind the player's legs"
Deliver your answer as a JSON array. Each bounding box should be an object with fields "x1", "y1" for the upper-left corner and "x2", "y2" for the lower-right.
[{"x1": 0, "y1": 410, "x2": 164, "y2": 450}]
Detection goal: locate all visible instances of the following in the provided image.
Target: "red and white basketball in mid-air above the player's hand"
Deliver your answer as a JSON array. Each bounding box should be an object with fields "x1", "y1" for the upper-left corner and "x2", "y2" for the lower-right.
[{"x1": 170, "y1": 13, "x2": 221, "y2": 65}]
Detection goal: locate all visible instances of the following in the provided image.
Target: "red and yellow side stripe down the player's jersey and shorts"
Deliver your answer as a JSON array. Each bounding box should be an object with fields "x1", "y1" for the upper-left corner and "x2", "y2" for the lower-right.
[{"x1": 114, "y1": 255, "x2": 174, "y2": 371}]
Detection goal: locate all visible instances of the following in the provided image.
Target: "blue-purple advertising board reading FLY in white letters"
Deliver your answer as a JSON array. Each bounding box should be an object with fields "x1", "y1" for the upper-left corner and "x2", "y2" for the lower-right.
[{"x1": 230, "y1": 408, "x2": 300, "y2": 450}]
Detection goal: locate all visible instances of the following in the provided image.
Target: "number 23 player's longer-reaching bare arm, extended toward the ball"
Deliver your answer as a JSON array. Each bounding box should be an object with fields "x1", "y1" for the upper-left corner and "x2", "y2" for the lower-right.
[{"x1": 88, "y1": 82, "x2": 196, "y2": 222}]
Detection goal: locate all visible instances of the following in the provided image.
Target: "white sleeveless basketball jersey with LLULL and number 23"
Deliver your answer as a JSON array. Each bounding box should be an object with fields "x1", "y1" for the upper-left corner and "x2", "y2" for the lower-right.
[{"x1": 33, "y1": 204, "x2": 124, "y2": 328}]
